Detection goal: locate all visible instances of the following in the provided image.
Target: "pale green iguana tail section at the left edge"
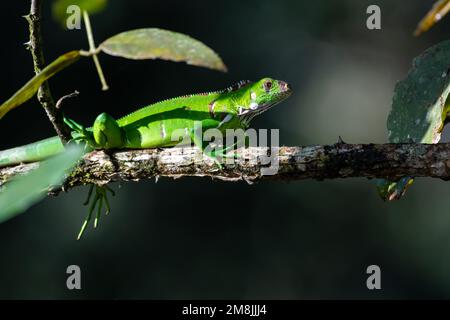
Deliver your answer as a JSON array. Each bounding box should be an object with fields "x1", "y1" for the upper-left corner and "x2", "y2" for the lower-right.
[{"x1": 0, "y1": 137, "x2": 64, "y2": 167}]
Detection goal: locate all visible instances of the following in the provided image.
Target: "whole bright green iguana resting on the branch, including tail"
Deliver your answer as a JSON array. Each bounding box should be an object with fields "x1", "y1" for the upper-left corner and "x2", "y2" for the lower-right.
[{"x1": 0, "y1": 78, "x2": 291, "y2": 238}]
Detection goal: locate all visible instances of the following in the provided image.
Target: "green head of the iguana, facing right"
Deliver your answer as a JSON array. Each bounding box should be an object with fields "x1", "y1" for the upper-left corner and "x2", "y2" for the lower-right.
[{"x1": 238, "y1": 78, "x2": 292, "y2": 125}]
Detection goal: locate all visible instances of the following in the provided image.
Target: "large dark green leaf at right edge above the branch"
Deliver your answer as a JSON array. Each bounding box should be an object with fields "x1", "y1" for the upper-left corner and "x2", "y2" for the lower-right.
[{"x1": 387, "y1": 41, "x2": 450, "y2": 143}]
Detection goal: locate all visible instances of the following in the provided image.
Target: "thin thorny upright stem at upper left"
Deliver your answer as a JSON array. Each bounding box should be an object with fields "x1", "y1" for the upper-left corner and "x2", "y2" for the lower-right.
[{"x1": 25, "y1": 0, "x2": 70, "y2": 143}]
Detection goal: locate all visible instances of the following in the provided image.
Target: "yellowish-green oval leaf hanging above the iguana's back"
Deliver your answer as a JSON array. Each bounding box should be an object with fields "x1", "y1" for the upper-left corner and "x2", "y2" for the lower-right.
[{"x1": 99, "y1": 28, "x2": 227, "y2": 72}]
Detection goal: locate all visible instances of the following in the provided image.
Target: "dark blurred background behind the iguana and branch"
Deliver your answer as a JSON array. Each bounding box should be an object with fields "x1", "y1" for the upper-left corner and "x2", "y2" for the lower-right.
[{"x1": 0, "y1": 0, "x2": 450, "y2": 299}]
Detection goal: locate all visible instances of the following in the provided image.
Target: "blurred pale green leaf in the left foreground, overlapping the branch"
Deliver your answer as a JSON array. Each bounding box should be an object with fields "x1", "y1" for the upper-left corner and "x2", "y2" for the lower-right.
[{"x1": 0, "y1": 145, "x2": 84, "y2": 223}]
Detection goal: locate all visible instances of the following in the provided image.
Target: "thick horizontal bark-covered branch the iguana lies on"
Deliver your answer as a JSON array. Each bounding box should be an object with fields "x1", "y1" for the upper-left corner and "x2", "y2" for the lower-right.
[{"x1": 0, "y1": 143, "x2": 450, "y2": 190}]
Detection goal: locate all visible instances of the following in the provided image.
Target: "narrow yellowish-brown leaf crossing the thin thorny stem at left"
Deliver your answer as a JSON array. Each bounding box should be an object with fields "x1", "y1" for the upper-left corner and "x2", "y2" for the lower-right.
[{"x1": 0, "y1": 51, "x2": 80, "y2": 119}]
